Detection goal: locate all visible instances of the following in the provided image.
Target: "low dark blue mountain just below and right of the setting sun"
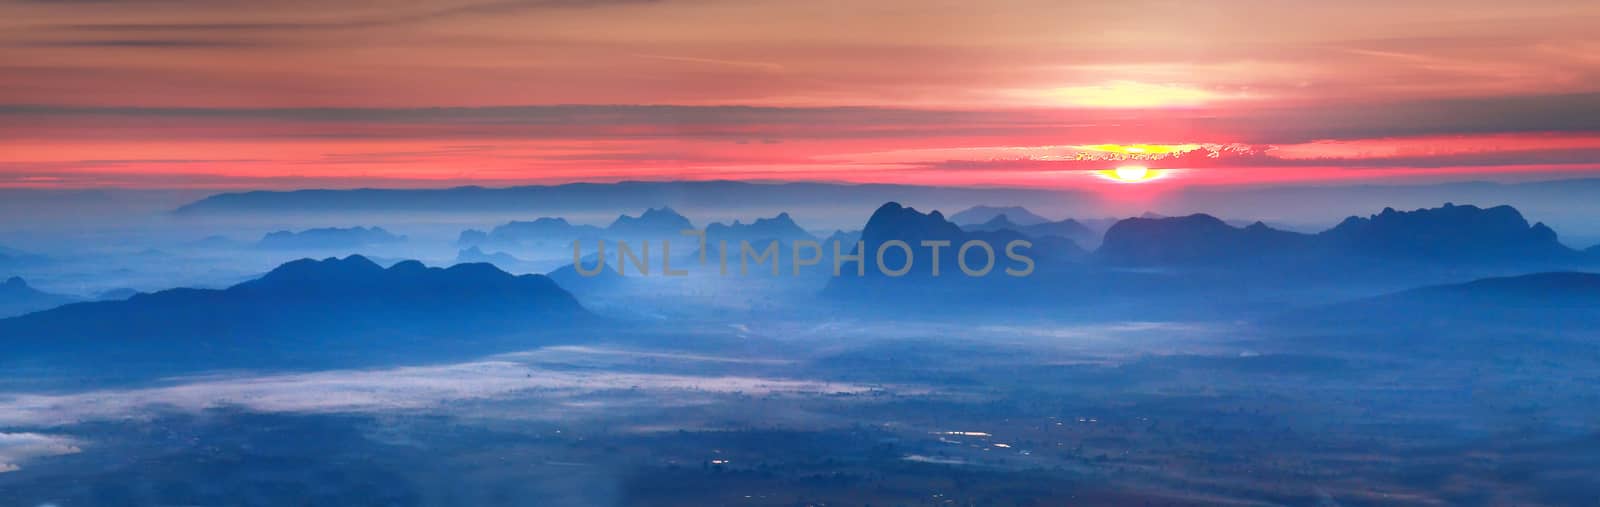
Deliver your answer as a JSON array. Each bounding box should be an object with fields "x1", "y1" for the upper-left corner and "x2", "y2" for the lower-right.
[{"x1": 1094, "y1": 214, "x2": 1314, "y2": 265}]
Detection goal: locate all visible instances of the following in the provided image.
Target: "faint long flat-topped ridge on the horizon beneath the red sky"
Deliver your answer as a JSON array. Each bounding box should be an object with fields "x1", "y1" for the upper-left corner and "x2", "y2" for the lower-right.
[{"x1": 165, "y1": 179, "x2": 1600, "y2": 237}]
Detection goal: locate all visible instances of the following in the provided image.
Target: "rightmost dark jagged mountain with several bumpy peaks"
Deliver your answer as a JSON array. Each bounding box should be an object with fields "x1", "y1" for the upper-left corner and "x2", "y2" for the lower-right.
[{"x1": 1318, "y1": 203, "x2": 1578, "y2": 264}]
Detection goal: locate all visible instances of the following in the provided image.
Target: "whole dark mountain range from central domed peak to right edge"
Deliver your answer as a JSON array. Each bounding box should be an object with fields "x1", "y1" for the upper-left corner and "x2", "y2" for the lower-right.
[{"x1": 826, "y1": 203, "x2": 1600, "y2": 318}]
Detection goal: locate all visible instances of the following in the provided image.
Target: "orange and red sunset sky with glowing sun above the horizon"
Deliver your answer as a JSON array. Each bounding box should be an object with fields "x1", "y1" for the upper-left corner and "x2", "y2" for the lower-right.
[{"x1": 0, "y1": 0, "x2": 1600, "y2": 192}]
